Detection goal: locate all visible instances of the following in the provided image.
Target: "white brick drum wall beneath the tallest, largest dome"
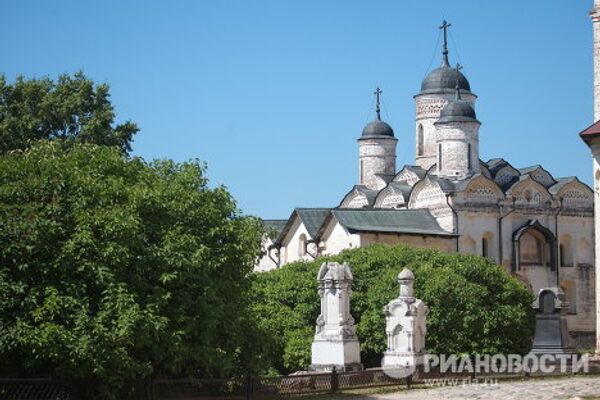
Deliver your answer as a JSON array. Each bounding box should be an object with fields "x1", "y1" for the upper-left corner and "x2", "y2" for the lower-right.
[{"x1": 415, "y1": 93, "x2": 476, "y2": 169}]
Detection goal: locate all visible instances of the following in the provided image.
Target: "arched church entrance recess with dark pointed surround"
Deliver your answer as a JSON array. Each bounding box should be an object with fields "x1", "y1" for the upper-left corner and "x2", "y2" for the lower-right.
[{"x1": 513, "y1": 220, "x2": 558, "y2": 295}]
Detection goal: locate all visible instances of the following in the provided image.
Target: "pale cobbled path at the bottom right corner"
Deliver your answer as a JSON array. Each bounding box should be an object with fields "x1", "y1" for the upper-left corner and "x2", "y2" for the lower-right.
[{"x1": 365, "y1": 375, "x2": 600, "y2": 400}]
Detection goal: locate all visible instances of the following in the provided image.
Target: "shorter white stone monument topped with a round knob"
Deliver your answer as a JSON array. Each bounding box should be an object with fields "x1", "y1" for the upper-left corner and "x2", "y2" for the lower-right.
[{"x1": 381, "y1": 268, "x2": 429, "y2": 368}]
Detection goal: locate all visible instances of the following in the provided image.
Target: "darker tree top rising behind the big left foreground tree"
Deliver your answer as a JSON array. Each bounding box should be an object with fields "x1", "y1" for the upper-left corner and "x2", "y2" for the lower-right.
[{"x1": 0, "y1": 72, "x2": 138, "y2": 153}]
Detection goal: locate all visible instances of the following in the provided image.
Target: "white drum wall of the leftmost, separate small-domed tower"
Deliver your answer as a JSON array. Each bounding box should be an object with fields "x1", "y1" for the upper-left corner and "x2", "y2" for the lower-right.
[{"x1": 358, "y1": 136, "x2": 398, "y2": 190}]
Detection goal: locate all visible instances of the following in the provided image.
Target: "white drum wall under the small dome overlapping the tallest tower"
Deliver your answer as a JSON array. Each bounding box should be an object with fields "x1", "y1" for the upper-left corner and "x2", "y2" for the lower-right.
[{"x1": 436, "y1": 122, "x2": 481, "y2": 179}]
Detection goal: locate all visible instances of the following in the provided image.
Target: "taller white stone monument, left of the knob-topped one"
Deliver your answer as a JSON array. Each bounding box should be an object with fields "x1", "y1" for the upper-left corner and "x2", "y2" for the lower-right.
[{"x1": 311, "y1": 262, "x2": 363, "y2": 371}]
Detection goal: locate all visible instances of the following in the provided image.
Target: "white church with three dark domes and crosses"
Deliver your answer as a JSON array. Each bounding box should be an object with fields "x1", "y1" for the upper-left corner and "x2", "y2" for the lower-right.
[{"x1": 256, "y1": 21, "x2": 600, "y2": 347}]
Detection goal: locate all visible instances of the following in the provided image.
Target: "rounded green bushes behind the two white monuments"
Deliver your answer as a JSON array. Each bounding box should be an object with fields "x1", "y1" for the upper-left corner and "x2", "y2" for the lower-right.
[{"x1": 252, "y1": 245, "x2": 535, "y2": 373}]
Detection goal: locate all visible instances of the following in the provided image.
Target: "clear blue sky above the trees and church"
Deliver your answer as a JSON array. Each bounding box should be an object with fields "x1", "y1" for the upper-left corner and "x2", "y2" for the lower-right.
[{"x1": 0, "y1": 0, "x2": 592, "y2": 218}]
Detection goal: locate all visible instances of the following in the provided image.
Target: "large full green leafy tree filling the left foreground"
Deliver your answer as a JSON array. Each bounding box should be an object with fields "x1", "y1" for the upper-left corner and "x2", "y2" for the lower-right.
[{"x1": 0, "y1": 141, "x2": 262, "y2": 398}]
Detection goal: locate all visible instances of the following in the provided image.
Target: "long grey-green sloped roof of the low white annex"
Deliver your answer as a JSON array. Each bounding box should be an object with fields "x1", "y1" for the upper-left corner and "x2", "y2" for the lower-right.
[{"x1": 319, "y1": 208, "x2": 455, "y2": 236}]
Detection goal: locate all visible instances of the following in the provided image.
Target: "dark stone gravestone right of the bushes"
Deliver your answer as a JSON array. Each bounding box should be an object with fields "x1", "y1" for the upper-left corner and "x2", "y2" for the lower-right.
[{"x1": 531, "y1": 287, "x2": 575, "y2": 355}]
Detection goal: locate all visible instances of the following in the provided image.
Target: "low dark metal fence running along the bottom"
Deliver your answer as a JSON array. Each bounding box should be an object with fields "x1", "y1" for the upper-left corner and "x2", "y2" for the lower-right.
[{"x1": 0, "y1": 365, "x2": 600, "y2": 400}]
